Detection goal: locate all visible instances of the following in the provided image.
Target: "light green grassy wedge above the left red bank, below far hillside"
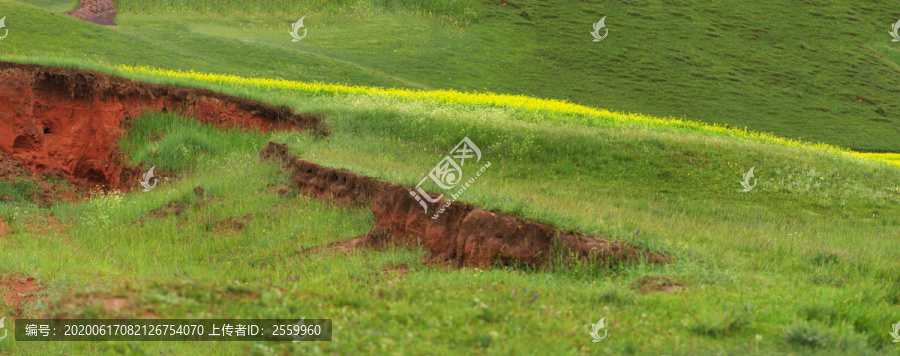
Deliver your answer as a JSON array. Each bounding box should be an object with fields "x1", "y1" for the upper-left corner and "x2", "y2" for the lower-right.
[{"x1": 0, "y1": 0, "x2": 402, "y2": 87}]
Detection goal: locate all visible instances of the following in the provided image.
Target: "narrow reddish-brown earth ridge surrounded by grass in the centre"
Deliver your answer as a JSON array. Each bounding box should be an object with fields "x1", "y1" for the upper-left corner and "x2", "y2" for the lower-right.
[{"x1": 259, "y1": 142, "x2": 666, "y2": 266}]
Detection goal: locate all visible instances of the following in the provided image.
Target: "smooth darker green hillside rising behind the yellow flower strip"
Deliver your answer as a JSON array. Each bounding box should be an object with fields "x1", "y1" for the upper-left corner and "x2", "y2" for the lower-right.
[{"x1": 8, "y1": 0, "x2": 900, "y2": 151}]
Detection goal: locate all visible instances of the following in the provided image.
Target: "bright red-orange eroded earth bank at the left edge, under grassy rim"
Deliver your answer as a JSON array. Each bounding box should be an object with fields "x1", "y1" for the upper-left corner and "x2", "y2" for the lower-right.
[{"x1": 0, "y1": 62, "x2": 327, "y2": 189}]
